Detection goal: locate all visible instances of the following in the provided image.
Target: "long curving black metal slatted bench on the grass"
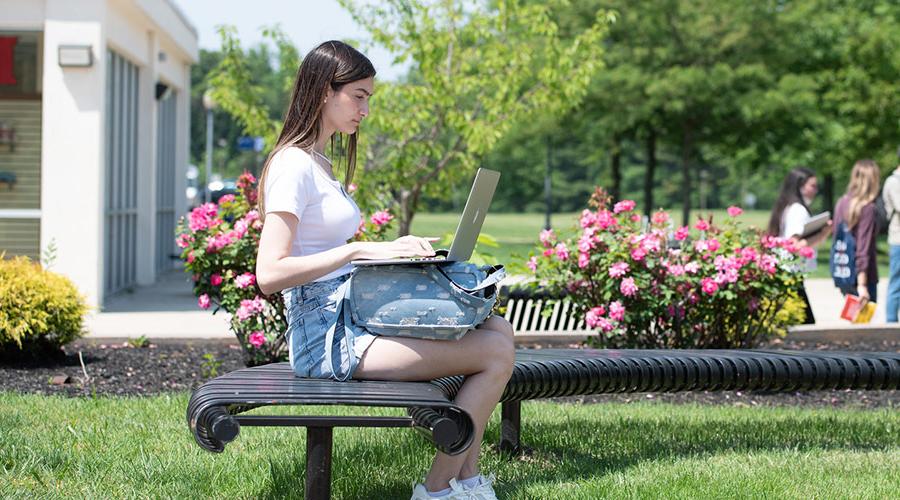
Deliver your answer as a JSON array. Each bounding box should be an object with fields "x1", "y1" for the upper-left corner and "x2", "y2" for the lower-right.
[{"x1": 187, "y1": 349, "x2": 900, "y2": 498}]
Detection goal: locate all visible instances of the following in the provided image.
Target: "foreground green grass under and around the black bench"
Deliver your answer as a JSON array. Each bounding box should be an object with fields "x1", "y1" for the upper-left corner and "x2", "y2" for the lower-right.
[{"x1": 0, "y1": 393, "x2": 900, "y2": 499}]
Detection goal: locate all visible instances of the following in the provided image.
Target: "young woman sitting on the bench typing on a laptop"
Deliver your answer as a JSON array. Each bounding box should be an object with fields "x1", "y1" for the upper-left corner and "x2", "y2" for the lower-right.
[{"x1": 256, "y1": 41, "x2": 514, "y2": 499}]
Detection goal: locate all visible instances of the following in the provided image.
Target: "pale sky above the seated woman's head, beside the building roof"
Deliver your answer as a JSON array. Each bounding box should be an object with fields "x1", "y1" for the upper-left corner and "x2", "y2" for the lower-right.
[{"x1": 173, "y1": 0, "x2": 406, "y2": 80}]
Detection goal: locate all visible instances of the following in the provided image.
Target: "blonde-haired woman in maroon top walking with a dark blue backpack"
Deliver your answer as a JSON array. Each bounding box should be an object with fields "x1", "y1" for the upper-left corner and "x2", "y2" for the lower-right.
[{"x1": 834, "y1": 160, "x2": 881, "y2": 302}]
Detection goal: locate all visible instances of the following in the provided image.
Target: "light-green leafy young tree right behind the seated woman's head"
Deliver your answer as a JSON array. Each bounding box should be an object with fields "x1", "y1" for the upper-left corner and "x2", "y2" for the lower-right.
[{"x1": 341, "y1": 0, "x2": 611, "y2": 234}]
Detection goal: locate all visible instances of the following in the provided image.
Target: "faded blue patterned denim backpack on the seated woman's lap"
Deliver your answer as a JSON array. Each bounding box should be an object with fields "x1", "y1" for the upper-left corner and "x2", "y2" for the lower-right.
[{"x1": 347, "y1": 262, "x2": 506, "y2": 340}]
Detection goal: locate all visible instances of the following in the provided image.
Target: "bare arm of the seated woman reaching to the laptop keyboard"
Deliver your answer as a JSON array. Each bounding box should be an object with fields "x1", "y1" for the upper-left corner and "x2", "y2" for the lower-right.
[{"x1": 256, "y1": 212, "x2": 434, "y2": 295}]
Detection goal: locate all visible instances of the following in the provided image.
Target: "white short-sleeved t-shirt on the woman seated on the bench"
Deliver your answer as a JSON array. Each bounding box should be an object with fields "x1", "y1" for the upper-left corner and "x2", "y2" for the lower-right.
[{"x1": 265, "y1": 147, "x2": 361, "y2": 281}]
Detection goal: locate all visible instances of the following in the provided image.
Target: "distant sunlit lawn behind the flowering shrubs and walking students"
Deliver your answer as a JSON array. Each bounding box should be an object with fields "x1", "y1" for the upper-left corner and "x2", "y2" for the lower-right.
[{"x1": 412, "y1": 206, "x2": 889, "y2": 279}]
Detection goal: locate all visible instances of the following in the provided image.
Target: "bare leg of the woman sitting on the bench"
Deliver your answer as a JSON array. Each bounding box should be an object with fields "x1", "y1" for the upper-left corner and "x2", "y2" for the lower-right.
[{"x1": 353, "y1": 318, "x2": 515, "y2": 491}]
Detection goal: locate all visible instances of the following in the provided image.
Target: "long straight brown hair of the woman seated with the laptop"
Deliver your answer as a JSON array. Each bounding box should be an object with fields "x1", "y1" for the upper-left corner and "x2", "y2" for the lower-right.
[{"x1": 257, "y1": 40, "x2": 375, "y2": 219}]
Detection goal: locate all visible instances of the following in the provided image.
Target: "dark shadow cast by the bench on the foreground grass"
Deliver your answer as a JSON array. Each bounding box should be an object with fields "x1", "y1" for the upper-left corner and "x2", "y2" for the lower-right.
[{"x1": 254, "y1": 408, "x2": 900, "y2": 498}]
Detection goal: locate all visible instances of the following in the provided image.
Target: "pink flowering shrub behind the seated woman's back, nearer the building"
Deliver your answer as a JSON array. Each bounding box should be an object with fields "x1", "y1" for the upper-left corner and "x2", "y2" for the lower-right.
[{"x1": 175, "y1": 172, "x2": 393, "y2": 366}]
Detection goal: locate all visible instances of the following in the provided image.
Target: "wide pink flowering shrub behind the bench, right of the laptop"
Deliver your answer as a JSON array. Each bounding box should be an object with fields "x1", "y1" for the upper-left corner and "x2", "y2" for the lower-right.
[{"x1": 528, "y1": 189, "x2": 812, "y2": 348}]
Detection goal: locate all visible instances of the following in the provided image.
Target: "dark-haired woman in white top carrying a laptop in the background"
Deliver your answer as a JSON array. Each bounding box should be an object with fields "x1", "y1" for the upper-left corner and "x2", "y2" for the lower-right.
[{"x1": 768, "y1": 167, "x2": 831, "y2": 324}]
